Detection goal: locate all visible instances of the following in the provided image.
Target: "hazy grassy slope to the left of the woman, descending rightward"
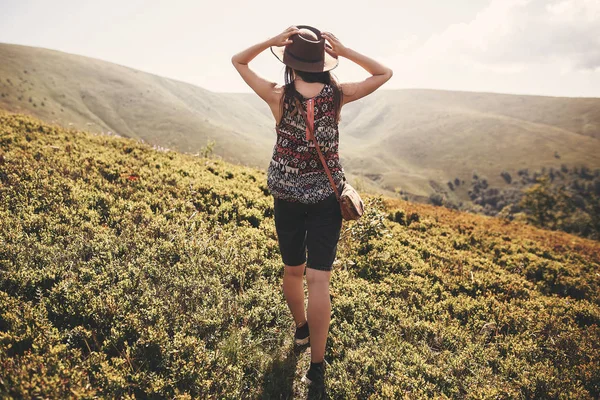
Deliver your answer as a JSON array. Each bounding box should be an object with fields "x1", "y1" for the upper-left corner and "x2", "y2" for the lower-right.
[{"x1": 0, "y1": 44, "x2": 275, "y2": 167}]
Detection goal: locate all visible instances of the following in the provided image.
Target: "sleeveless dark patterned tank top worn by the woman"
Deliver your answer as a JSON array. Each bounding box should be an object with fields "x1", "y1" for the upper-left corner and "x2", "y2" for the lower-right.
[{"x1": 267, "y1": 83, "x2": 345, "y2": 204}]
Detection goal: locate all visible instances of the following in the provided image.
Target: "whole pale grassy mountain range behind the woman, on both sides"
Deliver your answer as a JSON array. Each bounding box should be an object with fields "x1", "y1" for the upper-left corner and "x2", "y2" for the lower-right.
[{"x1": 0, "y1": 44, "x2": 600, "y2": 201}]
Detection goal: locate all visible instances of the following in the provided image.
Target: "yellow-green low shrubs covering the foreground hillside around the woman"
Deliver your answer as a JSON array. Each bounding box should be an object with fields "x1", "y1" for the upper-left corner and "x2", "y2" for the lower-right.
[{"x1": 0, "y1": 113, "x2": 600, "y2": 399}]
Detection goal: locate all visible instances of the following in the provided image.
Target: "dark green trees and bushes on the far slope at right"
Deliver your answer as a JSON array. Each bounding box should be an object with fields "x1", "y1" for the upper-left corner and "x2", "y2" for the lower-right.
[{"x1": 422, "y1": 164, "x2": 600, "y2": 240}]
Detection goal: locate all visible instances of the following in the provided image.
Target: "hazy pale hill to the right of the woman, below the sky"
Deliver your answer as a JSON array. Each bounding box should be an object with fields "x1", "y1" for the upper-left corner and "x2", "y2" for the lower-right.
[{"x1": 343, "y1": 90, "x2": 600, "y2": 195}]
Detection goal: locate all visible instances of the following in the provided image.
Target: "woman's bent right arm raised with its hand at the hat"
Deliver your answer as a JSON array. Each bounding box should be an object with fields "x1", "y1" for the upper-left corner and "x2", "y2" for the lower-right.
[{"x1": 321, "y1": 32, "x2": 393, "y2": 104}]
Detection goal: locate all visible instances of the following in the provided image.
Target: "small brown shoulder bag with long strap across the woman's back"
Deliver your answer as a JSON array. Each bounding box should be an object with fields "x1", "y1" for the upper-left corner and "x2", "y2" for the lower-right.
[{"x1": 296, "y1": 98, "x2": 365, "y2": 220}]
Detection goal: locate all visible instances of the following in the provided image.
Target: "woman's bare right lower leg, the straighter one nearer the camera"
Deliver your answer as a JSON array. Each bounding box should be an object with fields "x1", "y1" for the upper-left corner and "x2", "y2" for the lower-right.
[{"x1": 306, "y1": 268, "x2": 331, "y2": 363}]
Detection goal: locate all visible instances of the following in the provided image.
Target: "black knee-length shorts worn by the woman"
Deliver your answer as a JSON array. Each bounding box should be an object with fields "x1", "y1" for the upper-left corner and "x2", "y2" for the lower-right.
[{"x1": 274, "y1": 193, "x2": 342, "y2": 271}]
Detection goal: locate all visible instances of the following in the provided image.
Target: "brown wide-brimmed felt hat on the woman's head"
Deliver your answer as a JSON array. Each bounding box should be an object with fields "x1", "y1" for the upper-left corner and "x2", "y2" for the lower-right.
[{"x1": 271, "y1": 25, "x2": 338, "y2": 72}]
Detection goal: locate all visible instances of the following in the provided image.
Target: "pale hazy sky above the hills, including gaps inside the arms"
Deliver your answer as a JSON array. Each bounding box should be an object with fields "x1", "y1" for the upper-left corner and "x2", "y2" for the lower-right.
[{"x1": 0, "y1": 0, "x2": 600, "y2": 97}]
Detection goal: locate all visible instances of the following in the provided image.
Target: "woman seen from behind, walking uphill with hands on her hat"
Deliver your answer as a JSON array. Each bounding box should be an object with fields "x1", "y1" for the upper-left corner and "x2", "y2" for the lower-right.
[{"x1": 231, "y1": 25, "x2": 392, "y2": 384}]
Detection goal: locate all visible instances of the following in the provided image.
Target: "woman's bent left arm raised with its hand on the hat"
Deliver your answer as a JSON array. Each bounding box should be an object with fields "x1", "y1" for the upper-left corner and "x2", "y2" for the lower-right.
[{"x1": 231, "y1": 26, "x2": 298, "y2": 105}]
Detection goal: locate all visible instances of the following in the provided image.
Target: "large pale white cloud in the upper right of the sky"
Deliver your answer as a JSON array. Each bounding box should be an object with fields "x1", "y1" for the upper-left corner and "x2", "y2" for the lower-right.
[{"x1": 413, "y1": 0, "x2": 600, "y2": 73}]
